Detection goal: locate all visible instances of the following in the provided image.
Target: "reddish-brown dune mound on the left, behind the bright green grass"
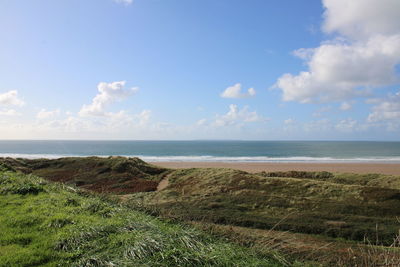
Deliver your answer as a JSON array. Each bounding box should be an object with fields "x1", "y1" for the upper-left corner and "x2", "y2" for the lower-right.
[{"x1": 0, "y1": 157, "x2": 168, "y2": 194}]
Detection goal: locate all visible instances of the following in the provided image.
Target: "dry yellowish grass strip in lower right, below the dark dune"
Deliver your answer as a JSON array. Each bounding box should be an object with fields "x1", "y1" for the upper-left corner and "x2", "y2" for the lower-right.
[{"x1": 192, "y1": 222, "x2": 400, "y2": 267}]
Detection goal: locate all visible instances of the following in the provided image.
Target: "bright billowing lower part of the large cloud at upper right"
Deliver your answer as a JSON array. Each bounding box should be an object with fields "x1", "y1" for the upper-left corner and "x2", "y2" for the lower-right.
[{"x1": 276, "y1": 35, "x2": 400, "y2": 103}]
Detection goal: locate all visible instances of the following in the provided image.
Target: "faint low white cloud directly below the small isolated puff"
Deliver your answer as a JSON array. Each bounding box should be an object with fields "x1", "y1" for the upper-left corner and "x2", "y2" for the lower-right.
[{"x1": 214, "y1": 104, "x2": 265, "y2": 126}]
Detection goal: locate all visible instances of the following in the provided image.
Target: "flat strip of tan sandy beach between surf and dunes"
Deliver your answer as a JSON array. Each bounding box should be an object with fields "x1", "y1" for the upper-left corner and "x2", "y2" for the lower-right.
[{"x1": 152, "y1": 162, "x2": 400, "y2": 175}]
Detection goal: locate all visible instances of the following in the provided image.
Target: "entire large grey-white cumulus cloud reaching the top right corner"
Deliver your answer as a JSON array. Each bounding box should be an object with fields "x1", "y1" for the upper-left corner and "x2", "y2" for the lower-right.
[{"x1": 275, "y1": 0, "x2": 400, "y2": 103}]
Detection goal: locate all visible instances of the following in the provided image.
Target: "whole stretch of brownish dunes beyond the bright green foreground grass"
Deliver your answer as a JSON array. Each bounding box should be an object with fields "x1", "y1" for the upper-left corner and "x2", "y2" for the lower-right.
[{"x1": 0, "y1": 157, "x2": 400, "y2": 266}]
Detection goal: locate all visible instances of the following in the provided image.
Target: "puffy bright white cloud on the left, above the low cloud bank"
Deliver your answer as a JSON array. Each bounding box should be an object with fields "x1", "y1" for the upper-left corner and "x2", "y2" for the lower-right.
[{"x1": 79, "y1": 81, "x2": 139, "y2": 116}]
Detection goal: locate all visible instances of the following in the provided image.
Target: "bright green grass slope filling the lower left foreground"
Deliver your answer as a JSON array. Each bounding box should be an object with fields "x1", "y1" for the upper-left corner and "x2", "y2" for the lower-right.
[{"x1": 0, "y1": 170, "x2": 282, "y2": 266}]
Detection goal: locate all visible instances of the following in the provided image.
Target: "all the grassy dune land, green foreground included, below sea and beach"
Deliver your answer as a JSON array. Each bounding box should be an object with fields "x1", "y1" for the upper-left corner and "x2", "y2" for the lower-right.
[{"x1": 0, "y1": 157, "x2": 400, "y2": 266}]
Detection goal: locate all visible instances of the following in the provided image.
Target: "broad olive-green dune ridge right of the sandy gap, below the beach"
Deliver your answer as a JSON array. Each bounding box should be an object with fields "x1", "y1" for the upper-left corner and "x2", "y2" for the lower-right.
[{"x1": 126, "y1": 169, "x2": 400, "y2": 244}]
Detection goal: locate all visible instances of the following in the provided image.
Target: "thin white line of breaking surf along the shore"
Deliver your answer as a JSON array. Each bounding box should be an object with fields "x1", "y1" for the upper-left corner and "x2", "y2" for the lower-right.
[{"x1": 0, "y1": 153, "x2": 400, "y2": 163}]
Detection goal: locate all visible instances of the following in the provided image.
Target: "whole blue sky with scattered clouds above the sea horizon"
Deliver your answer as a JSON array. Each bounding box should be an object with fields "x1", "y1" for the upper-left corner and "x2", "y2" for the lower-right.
[{"x1": 0, "y1": 0, "x2": 400, "y2": 141}]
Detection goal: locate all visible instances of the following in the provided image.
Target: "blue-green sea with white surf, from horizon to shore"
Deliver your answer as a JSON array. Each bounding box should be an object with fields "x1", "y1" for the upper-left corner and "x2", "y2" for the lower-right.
[{"x1": 0, "y1": 141, "x2": 400, "y2": 163}]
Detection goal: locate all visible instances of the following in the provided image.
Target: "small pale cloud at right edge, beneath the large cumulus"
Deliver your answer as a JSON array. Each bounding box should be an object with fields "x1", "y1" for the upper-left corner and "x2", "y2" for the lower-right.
[{"x1": 367, "y1": 92, "x2": 400, "y2": 123}]
